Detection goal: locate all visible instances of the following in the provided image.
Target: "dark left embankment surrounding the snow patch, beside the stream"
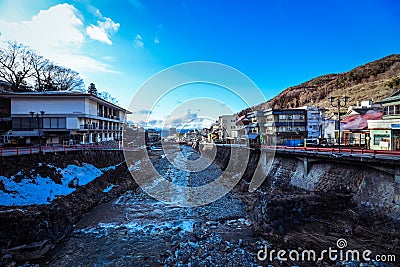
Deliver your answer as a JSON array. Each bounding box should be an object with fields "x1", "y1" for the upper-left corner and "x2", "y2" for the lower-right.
[{"x1": 0, "y1": 151, "x2": 141, "y2": 265}]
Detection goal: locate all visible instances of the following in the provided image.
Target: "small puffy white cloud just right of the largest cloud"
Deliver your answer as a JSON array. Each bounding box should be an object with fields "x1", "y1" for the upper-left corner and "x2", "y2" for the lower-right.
[{"x1": 86, "y1": 17, "x2": 120, "y2": 45}]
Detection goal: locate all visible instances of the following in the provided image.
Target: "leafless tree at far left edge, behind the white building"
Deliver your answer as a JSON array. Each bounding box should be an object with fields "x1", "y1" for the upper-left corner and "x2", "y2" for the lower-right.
[{"x1": 0, "y1": 42, "x2": 34, "y2": 91}]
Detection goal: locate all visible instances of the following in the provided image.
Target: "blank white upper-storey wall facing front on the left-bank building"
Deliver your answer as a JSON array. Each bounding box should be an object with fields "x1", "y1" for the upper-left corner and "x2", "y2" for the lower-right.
[{"x1": 11, "y1": 97, "x2": 85, "y2": 115}]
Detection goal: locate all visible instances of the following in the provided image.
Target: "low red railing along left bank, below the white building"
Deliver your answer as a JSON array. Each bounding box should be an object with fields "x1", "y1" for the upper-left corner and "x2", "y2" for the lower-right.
[{"x1": 0, "y1": 144, "x2": 122, "y2": 157}]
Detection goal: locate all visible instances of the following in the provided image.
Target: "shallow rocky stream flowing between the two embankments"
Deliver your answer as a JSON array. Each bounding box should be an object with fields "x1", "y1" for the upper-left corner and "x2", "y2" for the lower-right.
[{"x1": 38, "y1": 147, "x2": 263, "y2": 266}]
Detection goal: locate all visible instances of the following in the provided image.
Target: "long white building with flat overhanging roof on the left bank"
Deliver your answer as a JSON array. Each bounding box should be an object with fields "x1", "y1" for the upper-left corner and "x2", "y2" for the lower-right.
[{"x1": 3, "y1": 91, "x2": 130, "y2": 147}]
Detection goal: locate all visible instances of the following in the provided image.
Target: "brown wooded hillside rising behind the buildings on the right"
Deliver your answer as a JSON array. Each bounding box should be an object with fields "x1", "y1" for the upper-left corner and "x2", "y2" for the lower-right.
[{"x1": 240, "y1": 54, "x2": 400, "y2": 114}]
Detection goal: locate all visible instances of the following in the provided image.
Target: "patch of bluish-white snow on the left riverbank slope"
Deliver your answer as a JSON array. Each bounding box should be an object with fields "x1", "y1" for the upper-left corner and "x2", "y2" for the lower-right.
[{"x1": 0, "y1": 164, "x2": 103, "y2": 206}]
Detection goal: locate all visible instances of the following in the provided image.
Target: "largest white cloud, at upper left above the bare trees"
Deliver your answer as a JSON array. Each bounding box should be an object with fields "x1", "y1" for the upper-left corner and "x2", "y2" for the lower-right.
[{"x1": 0, "y1": 4, "x2": 119, "y2": 75}]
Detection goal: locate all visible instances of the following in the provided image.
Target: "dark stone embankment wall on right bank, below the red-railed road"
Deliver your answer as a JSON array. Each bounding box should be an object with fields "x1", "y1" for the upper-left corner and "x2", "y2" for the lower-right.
[{"x1": 199, "y1": 146, "x2": 400, "y2": 262}]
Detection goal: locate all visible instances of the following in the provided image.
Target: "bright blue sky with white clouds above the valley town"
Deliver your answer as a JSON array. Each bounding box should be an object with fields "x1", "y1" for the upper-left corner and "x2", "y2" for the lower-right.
[{"x1": 0, "y1": 0, "x2": 400, "y2": 129}]
